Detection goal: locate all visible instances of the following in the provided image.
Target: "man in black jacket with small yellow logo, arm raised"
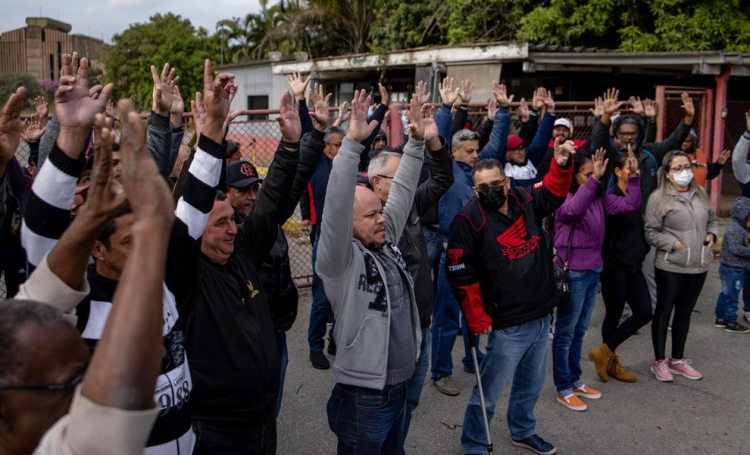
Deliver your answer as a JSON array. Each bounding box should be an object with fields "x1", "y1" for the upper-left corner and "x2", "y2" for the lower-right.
[{"x1": 184, "y1": 92, "x2": 301, "y2": 454}]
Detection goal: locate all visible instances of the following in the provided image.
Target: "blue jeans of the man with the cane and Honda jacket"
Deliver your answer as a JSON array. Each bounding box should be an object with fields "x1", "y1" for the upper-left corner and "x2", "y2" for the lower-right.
[{"x1": 461, "y1": 316, "x2": 550, "y2": 454}]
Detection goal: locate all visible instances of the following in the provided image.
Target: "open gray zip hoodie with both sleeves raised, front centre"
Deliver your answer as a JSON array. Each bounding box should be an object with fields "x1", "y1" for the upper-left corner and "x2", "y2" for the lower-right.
[{"x1": 315, "y1": 139, "x2": 424, "y2": 390}]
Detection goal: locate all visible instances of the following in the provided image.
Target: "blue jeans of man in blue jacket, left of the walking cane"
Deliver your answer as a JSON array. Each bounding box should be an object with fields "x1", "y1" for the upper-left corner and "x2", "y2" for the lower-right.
[{"x1": 432, "y1": 253, "x2": 484, "y2": 381}]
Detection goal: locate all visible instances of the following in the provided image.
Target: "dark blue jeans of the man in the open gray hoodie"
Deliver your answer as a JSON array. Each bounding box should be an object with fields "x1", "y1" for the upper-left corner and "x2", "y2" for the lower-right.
[{"x1": 327, "y1": 382, "x2": 406, "y2": 455}]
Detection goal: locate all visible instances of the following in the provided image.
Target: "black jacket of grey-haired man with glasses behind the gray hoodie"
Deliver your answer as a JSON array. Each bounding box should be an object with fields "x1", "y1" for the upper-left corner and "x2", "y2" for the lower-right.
[{"x1": 398, "y1": 138, "x2": 453, "y2": 329}]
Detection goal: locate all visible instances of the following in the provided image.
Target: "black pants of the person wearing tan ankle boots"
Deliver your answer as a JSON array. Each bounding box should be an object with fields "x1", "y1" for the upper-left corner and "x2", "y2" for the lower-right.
[{"x1": 601, "y1": 265, "x2": 652, "y2": 352}]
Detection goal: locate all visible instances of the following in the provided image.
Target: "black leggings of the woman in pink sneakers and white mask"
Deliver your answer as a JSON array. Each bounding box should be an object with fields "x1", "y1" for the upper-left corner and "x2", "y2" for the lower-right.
[{"x1": 651, "y1": 269, "x2": 706, "y2": 360}]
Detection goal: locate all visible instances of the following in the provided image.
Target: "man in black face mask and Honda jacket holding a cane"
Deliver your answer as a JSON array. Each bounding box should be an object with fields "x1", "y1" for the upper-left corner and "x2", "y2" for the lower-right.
[{"x1": 446, "y1": 140, "x2": 574, "y2": 454}]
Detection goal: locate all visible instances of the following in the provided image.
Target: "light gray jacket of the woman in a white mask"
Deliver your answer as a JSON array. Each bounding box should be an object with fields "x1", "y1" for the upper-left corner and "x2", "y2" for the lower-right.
[{"x1": 646, "y1": 185, "x2": 719, "y2": 274}]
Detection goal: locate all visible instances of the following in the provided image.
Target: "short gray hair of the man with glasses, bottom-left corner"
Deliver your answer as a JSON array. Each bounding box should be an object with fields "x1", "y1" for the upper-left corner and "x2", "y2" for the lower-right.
[{"x1": 0, "y1": 299, "x2": 64, "y2": 384}]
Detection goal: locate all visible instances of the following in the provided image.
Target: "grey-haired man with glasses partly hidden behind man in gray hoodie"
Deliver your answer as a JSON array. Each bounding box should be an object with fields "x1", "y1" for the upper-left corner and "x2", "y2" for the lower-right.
[{"x1": 367, "y1": 122, "x2": 453, "y2": 451}]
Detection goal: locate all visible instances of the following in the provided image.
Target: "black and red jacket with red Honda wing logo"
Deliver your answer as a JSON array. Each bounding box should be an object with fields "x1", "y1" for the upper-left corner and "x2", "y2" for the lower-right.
[{"x1": 446, "y1": 158, "x2": 573, "y2": 333}]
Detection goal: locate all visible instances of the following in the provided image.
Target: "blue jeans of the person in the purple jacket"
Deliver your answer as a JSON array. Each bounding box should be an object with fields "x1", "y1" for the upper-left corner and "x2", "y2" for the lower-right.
[{"x1": 552, "y1": 270, "x2": 599, "y2": 396}]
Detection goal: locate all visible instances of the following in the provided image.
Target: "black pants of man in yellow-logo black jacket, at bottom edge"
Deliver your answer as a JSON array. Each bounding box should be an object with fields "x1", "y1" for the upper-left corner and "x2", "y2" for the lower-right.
[{"x1": 193, "y1": 410, "x2": 276, "y2": 455}]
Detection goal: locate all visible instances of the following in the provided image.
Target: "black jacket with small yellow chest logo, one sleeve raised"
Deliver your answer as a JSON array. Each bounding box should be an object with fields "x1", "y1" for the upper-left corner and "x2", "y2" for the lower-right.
[{"x1": 181, "y1": 143, "x2": 298, "y2": 420}]
